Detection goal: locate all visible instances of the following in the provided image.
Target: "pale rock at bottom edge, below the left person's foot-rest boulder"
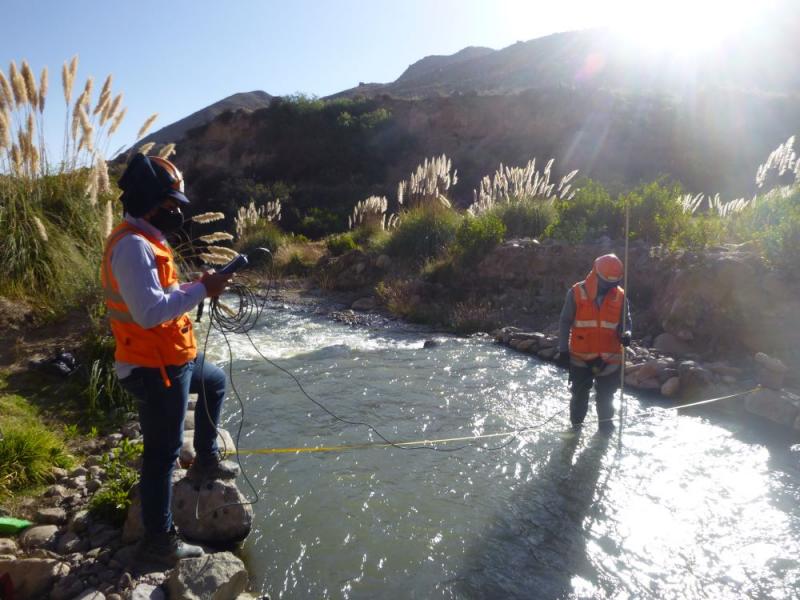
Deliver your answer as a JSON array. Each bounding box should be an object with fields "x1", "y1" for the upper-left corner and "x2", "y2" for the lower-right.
[{"x1": 165, "y1": 552, "x2": 247, "y2": 600}]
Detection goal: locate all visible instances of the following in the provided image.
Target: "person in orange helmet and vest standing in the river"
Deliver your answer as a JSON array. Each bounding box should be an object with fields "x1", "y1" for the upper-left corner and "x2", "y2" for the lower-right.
[{"x1": 558, "y1": 254, "x2": 631, "y2": 431}]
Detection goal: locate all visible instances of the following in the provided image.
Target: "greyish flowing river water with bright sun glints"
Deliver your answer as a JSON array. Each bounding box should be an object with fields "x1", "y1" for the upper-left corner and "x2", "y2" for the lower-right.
[{"x1": 202, "y1": 310, "x2": 800, "y2": 599}]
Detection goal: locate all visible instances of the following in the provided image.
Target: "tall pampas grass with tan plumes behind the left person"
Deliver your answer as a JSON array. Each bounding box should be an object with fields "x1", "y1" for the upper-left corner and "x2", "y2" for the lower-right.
[{"x1": 0, "y1": 56, "x2": 161, "y2": 310}]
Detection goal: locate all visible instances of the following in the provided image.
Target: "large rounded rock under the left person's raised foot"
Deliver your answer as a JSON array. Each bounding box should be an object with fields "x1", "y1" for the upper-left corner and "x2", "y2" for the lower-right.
[{"x1": 172, "y1": 479, "x2": 253, "y2": 545}]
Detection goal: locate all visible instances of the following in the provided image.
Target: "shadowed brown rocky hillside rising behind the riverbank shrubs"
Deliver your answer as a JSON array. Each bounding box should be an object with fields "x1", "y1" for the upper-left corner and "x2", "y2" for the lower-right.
[{"x1": 152, "y1": 9, "x2": 800, "y2": 227}]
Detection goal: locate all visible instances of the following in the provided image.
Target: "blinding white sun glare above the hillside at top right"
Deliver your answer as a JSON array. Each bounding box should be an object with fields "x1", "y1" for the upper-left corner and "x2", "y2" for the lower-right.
[{"x1": 613, "y1": 0, "x2": 768, "y2": 56}]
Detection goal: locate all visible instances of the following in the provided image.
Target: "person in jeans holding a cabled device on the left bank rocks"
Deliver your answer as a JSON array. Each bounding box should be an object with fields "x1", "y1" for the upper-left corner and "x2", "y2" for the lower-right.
[{"x1": 101, "y1": 154, "x2": 238, "y2": 566}]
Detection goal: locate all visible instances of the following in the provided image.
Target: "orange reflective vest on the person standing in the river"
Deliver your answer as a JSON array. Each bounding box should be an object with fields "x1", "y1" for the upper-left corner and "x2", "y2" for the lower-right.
[{"x1": 569, "y1": 273, "x2": 625, "y2": 364}]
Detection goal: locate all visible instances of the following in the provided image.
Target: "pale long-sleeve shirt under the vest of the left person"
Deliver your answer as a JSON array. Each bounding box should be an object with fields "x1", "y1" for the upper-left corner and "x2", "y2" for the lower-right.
[{"x1": 111, "y1": 215, "x2": 206, "y2": 379}]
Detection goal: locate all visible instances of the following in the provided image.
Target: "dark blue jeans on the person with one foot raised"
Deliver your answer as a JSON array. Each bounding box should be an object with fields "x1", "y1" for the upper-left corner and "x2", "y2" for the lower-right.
[{"x1": 120, "y1": 353, "x2": 225, "y2": 534}]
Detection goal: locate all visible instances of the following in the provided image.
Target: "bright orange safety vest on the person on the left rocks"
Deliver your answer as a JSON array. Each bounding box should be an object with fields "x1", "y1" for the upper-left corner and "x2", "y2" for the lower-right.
[{"x1": 101, "y1": 221, "x2": 197, "y2": 387}]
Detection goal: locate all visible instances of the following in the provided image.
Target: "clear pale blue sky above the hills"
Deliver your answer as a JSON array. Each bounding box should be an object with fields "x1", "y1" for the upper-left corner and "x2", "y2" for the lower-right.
[{"x1": 0, "y1": 0, "x2": 776, "y2": 156}]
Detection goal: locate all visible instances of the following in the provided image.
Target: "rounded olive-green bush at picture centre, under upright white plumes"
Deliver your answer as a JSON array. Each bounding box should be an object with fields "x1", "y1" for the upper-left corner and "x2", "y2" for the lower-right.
[{"x1": 386, "y1": 205, "x2": 462, "y2": 262}]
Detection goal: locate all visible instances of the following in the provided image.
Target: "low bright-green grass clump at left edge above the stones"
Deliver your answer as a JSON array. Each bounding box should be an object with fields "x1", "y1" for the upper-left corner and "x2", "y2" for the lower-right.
[{"x1": 0, "y1": 422, "x2": 72, "y2": 490}]
